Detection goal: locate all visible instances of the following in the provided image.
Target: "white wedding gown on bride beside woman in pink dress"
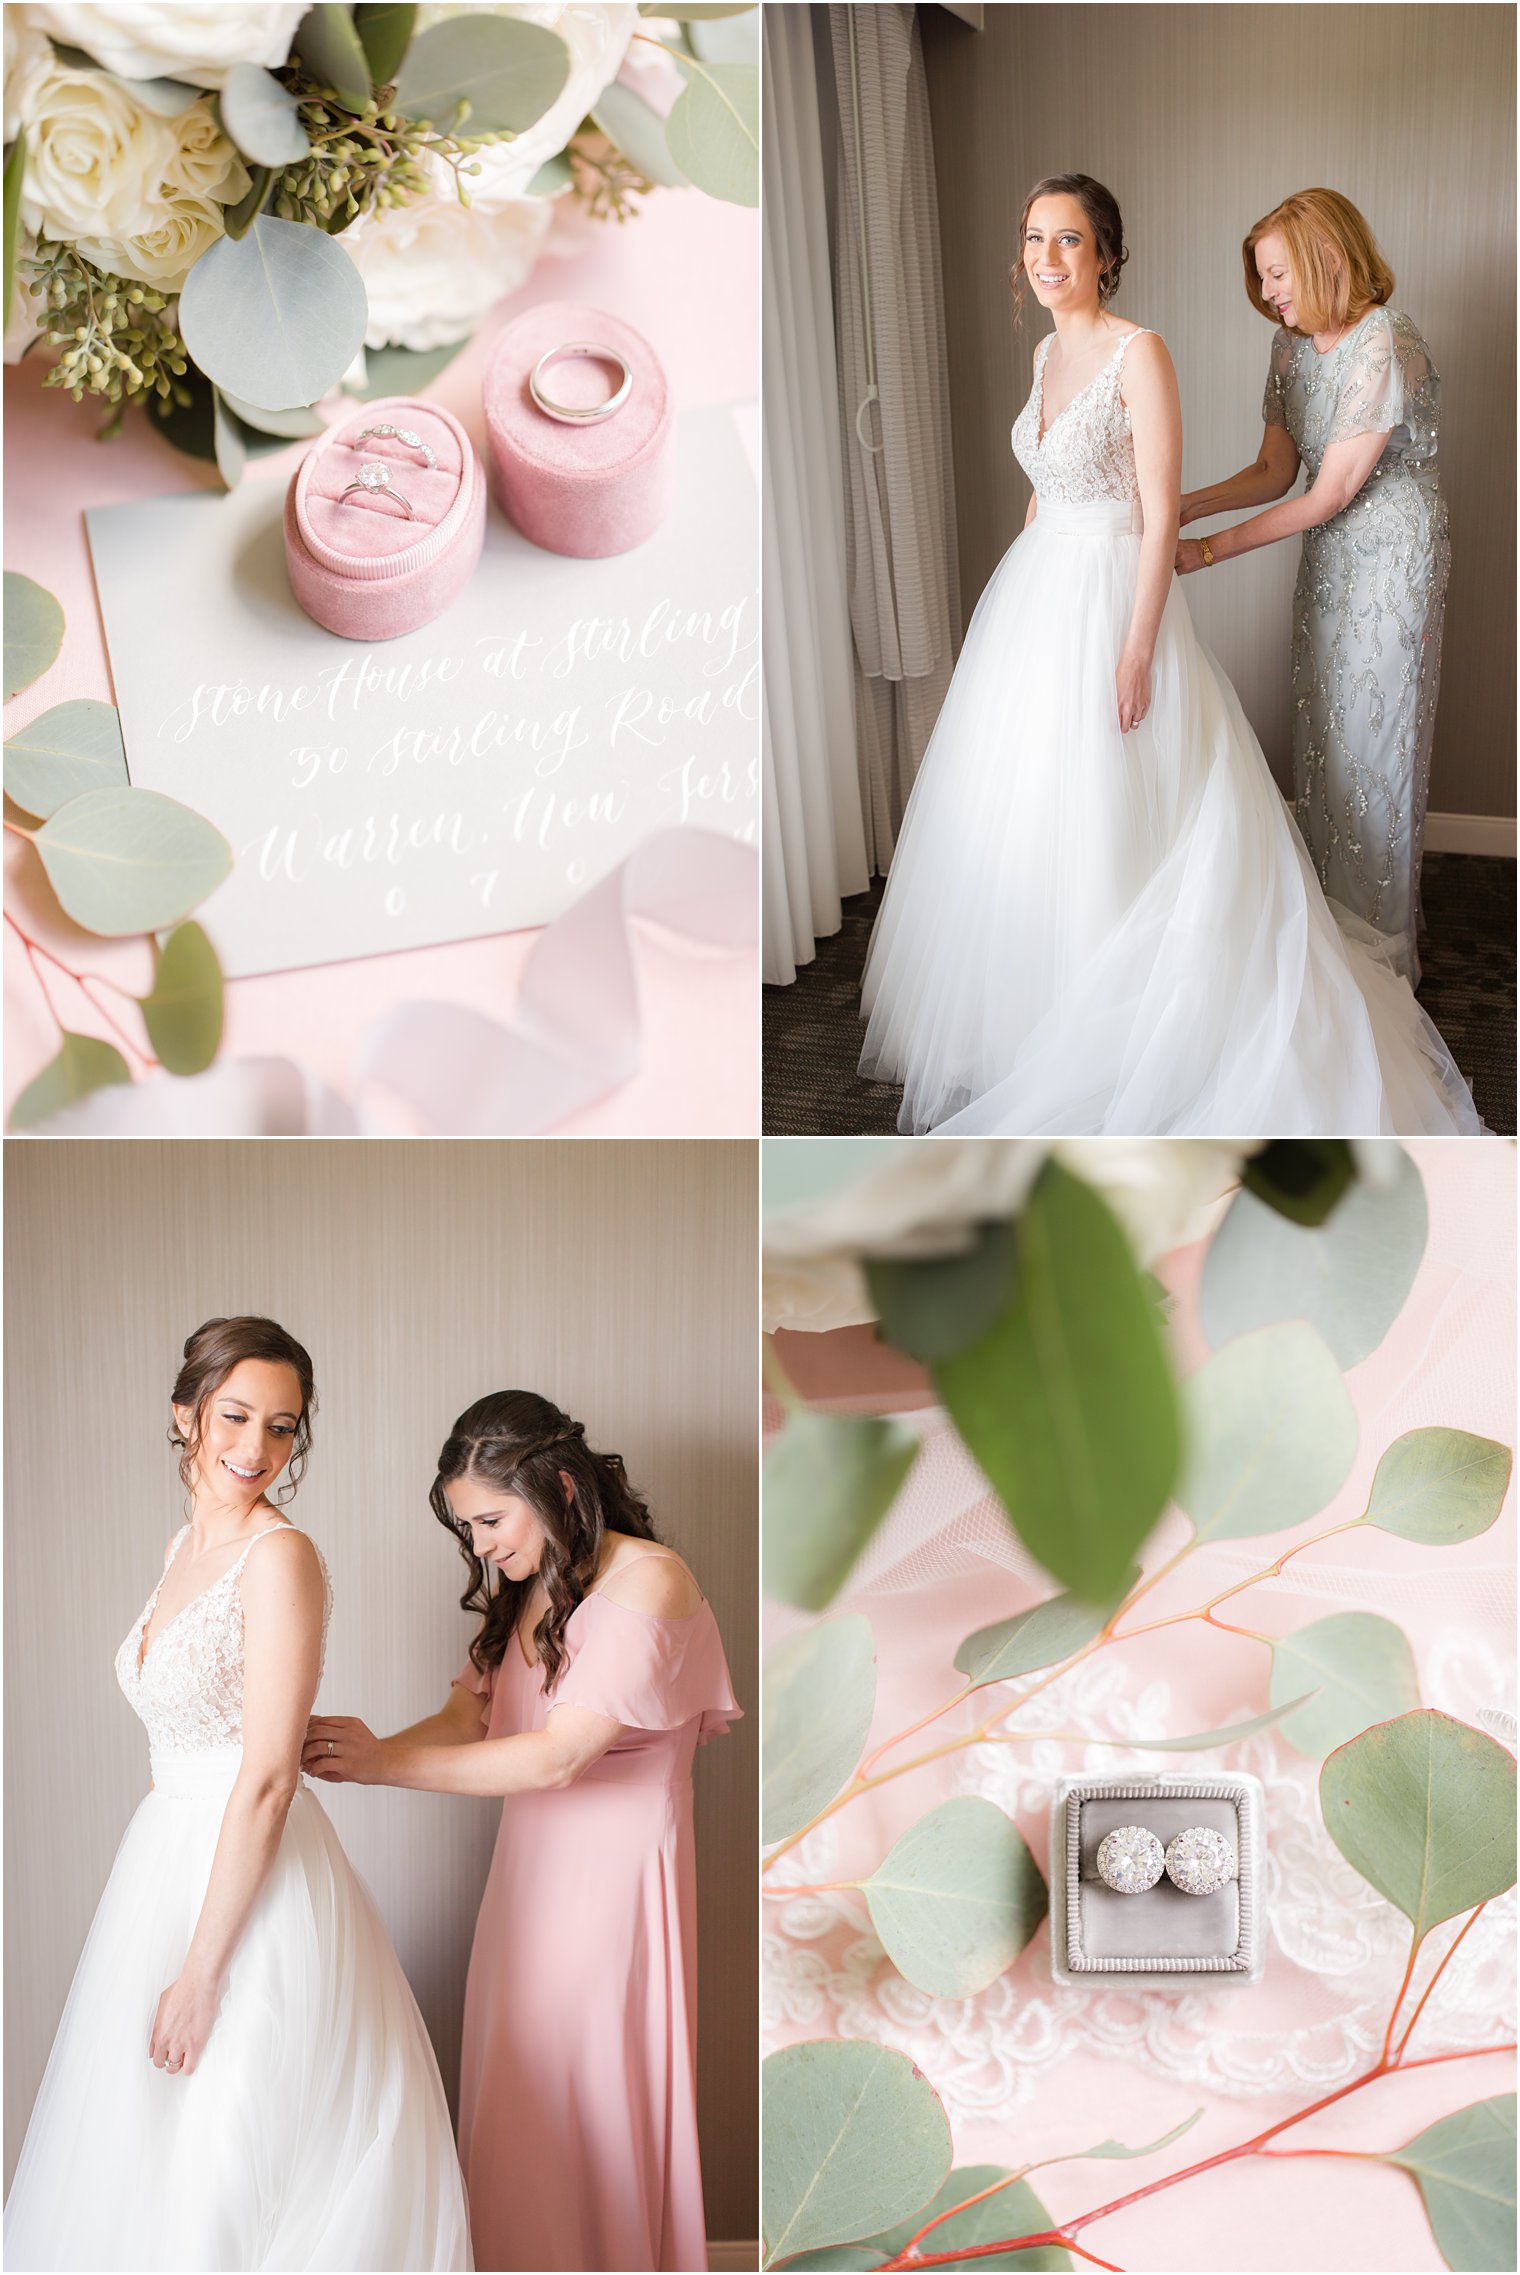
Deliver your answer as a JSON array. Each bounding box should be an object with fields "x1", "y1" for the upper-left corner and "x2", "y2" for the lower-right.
[{"x1": 5, "y1": 1533, "x2": 471, "y2": 2270}]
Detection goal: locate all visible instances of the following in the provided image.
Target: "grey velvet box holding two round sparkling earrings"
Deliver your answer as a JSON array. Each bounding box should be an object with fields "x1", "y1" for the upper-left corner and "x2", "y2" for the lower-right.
[{"x1": 1051, "y1": 1775, "x2": 1265, "y2": 1991}]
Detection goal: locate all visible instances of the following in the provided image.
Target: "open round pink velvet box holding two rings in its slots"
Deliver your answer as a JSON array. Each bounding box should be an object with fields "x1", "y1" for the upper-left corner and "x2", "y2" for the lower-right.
[{"x1": 284, "y1": 396, "x2": 485, "y2": 639}]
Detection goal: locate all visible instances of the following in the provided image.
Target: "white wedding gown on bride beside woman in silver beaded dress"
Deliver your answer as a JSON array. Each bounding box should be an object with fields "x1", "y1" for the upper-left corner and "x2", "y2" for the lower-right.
[{"x1": 860, "y1": 332, "x2": 1481, "y2": 1138}]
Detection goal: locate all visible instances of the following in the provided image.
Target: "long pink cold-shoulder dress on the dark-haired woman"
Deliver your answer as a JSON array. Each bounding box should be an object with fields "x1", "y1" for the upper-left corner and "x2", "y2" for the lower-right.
[{"x1": 457, "y1": 1593, "x2": 740, "y2": 2270}]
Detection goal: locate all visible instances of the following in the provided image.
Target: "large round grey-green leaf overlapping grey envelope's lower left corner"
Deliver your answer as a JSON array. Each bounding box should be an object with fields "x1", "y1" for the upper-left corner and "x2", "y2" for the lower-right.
[{"x1": 32, "y1": 789, "x2": 232, "y2": 940}]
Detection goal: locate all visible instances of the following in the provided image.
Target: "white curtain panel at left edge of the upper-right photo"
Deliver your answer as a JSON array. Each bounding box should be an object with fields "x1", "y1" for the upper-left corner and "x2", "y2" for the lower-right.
[{"x1": 762, "y1": 7, "x2": 869, "y2": 981}]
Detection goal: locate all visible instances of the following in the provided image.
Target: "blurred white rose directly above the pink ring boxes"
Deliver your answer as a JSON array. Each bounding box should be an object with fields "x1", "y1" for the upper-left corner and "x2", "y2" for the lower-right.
[{"x1": 337, "y1": 175, "x2": 553, "y2": 348}]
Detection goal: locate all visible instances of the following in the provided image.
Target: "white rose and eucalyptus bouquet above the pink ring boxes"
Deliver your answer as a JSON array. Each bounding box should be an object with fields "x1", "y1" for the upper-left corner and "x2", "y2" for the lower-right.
[{"x1": 5, "y1": 0, "x2": 760, "y2": 482}]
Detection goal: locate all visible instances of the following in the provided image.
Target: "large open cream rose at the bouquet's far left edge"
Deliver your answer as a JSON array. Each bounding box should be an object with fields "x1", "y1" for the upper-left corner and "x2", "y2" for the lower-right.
[{"x1": 20, "y1": 64, "x2": 175, "y2": 243}]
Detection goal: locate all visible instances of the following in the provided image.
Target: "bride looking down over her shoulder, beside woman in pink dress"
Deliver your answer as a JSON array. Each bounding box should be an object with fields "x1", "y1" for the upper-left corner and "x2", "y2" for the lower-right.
[{"x1": 5, "y1": 1320, "x2": 471, "y2": 2270}]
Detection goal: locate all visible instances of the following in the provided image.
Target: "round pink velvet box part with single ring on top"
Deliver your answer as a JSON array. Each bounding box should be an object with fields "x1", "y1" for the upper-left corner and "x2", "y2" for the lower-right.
[{"x1": 485, "y1": 300, "x2": 676, "y2": 560}]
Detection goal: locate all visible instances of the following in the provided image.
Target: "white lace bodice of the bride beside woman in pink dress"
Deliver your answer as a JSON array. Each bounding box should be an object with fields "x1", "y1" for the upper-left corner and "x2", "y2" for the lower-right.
[{"x1": 116, "y1": 1524, "x2": 332, "y2": 1754}]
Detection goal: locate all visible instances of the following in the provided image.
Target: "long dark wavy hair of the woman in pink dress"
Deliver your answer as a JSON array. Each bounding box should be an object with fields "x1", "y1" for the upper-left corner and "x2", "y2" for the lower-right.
[{"x1": 428, "y1": 1390, "x2": 655, "y2": 1690}]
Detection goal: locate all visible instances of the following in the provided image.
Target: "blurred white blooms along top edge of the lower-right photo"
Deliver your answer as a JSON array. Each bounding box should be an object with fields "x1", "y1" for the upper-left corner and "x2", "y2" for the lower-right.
[{"x1": 765, "y1": 1138, "x2": 1256, "y2": 1333}]
